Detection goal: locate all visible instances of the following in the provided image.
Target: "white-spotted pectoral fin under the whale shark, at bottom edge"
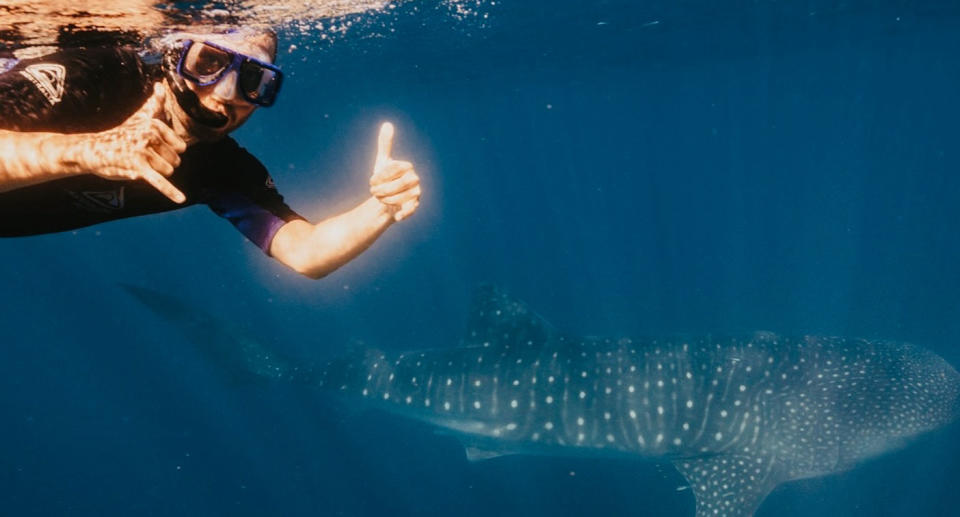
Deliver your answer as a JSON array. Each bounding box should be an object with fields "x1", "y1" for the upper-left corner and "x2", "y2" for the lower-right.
[{"x1": 673, "y1": 454, "x2": 781, "y2": 517}]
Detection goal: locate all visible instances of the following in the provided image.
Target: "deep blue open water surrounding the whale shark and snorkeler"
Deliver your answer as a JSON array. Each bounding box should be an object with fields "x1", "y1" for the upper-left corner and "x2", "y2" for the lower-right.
[{"x1": 0, "y1": 0, "x2": 960, "y2": 517}]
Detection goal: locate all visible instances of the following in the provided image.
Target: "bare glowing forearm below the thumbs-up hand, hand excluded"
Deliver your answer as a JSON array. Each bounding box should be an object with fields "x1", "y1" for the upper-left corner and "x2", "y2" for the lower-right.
[{"x1": 270, "y1": 198, "x2": 393, "y2": 278}]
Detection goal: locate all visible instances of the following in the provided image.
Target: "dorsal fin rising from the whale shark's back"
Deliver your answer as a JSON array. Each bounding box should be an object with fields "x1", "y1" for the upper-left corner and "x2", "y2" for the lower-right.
[{"x1": 465, "y1": 285, "x2": 553, "y2": 347}]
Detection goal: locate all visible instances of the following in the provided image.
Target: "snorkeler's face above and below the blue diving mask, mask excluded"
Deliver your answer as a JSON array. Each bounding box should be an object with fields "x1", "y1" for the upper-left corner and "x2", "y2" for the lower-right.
[{"x1": 170, "y1": 34, "x2": 276, "y2": 140}]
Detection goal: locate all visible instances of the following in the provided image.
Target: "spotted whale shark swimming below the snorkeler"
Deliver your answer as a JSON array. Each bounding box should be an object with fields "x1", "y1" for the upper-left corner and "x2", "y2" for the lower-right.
[{"x1": 127, "y1": 286, "x2": 960, "y2": 517}]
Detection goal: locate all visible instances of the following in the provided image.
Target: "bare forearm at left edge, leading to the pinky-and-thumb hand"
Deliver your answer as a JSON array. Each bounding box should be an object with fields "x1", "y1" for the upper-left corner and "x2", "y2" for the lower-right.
[{"x1": 0, "y1": 130, "x2": 83, "y2": 192}]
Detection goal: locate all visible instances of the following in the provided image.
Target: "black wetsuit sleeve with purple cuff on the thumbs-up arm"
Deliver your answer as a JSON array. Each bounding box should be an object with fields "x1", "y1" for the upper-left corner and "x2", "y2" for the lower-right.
[{"x1": 207, "y1": 139, "x2": 305, "y2": 255}]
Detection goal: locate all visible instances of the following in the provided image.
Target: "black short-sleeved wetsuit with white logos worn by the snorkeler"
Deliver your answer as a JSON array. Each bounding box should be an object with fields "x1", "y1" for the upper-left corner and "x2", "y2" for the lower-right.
[{"x1": 0, "y1": 47, "x2": 302, "y2": 252}]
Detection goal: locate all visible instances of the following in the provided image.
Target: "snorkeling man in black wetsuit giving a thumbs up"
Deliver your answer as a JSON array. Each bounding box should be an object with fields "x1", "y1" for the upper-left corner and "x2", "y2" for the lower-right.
[{"x1": 0, "y1": 30, "x2": 420, "y2": 278}]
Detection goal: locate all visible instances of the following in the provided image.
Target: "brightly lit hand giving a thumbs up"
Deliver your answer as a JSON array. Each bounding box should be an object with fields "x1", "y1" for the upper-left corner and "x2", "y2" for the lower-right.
[{"x1": 370, "y1": 122, "x2": 420, "y2": 221}]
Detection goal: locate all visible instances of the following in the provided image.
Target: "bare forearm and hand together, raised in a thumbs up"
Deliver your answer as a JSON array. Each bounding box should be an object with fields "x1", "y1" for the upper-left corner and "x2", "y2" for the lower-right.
[{"x1": 270, "y1": 123, "x2": 420, "y2": 278}]
